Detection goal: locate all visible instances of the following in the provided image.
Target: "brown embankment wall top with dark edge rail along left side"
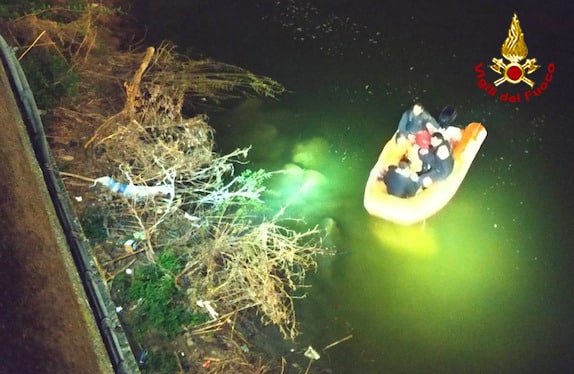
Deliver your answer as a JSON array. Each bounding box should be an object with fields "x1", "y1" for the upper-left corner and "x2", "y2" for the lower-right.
[{"x1": 0, "y1": 33, "x2": 139, "y2": 374}]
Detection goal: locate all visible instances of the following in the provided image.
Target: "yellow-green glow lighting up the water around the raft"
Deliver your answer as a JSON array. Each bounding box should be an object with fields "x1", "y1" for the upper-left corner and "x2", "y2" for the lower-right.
[{"x1": 212, "y1": 96, "x2": 568, "y2": 373}]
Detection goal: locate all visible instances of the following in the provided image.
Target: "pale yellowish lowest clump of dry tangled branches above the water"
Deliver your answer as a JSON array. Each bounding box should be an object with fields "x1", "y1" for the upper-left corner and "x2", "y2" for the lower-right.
[{"x1": 176, "y1": 221, "x2": 321, "y2": 338}]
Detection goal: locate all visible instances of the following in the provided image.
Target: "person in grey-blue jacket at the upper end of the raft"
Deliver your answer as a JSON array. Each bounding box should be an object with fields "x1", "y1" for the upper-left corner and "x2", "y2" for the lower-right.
[{"x1": 395, "y1": 103, "x2": 440, "y2": 147}]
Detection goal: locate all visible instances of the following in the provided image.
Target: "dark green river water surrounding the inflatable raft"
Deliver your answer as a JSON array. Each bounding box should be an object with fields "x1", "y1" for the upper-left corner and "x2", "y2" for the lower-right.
[{"x1": 139, "y1": 0, "x2": 574, "y2": 373}]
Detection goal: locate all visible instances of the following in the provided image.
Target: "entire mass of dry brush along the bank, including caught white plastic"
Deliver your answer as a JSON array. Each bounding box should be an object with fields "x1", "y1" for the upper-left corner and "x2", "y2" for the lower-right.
[{"x1": 2, "y1": 4, "x2": 325, "y2": 372}]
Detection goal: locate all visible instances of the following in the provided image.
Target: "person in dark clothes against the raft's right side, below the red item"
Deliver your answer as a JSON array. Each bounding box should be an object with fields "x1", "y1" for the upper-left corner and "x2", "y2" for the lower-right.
[{"x1": 419, "y1": 131, "x2": 454, "y2": 188}]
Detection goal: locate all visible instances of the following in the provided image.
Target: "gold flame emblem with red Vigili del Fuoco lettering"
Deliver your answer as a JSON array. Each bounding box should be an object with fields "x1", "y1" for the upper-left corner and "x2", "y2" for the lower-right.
[{"x1": 474, "y1": 13, "x2": 554, "y2": 103}]
